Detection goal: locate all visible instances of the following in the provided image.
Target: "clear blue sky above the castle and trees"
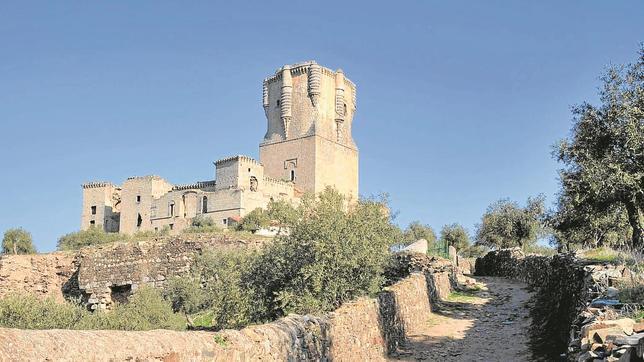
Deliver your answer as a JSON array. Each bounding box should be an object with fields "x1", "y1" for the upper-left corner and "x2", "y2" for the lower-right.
[{"x1": 0, "y1": 1, "x2": 644, "y2": 251}]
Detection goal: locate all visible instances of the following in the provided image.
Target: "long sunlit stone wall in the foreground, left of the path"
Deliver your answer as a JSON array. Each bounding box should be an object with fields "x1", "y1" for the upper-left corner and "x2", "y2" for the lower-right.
[{"x1": 0, "y1": 264, "x2": 449, "y2": 361}]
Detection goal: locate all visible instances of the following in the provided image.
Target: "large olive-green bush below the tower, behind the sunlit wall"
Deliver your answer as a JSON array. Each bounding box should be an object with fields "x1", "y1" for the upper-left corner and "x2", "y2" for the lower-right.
[{"x1": 244, "y1": 189, "x2": 397, "y2": 319}]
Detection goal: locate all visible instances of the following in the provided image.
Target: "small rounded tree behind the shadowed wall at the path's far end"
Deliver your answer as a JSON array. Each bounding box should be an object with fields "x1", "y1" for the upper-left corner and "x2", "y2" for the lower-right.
[{"x1": 476, "y1": 196, "x2": 545, "y2": 248}]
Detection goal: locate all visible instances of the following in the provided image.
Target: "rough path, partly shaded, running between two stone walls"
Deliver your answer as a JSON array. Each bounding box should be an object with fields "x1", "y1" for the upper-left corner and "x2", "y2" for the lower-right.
[{"x1": 393, "y1": 277, "x2": 530, "y2": 361}]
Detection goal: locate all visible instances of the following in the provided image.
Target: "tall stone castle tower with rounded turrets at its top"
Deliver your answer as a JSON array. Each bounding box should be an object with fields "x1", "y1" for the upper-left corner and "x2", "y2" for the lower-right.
[{"x1": 259, "y1": 61, "x2": 358, "y2": 199}]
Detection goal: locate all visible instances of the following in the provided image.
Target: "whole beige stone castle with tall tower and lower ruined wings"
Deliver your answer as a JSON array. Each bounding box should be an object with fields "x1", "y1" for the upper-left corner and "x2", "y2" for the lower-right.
[{"x1": 81, "y1": 61, "x2": 358, "y2": 234}]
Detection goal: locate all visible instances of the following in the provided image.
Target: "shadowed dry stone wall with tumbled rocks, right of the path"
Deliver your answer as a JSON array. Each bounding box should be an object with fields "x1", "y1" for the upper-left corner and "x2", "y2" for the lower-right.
[{"x1": 476, "y1": 248, "x2": 644, "y2": 362}]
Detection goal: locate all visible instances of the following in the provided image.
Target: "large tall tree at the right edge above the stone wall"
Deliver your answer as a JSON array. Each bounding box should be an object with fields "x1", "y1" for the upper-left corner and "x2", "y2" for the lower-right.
[{"x1": 555, "y1": 47, "x2": 644, "y2": 249}]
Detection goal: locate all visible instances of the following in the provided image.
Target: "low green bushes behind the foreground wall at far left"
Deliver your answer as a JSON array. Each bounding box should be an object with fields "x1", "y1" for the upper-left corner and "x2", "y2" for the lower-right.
[{"x1": 0, "y1": 287, "x2": 186, "y2": 331}]
